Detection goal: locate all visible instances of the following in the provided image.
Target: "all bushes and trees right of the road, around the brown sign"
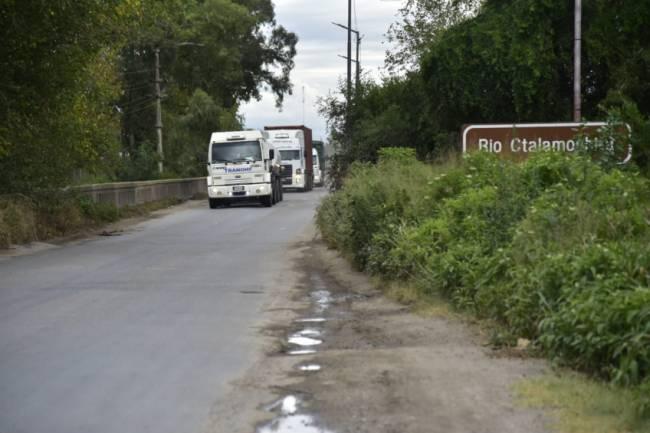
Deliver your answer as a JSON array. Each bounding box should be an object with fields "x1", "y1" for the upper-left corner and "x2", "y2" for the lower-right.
[{"x1": 317, "y1": 0, "x2": 650, "y2": 431}]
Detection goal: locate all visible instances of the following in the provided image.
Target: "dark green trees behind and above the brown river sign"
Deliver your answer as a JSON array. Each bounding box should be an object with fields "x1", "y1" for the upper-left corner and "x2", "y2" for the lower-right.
[{"x1": 321, "y1": 0, "x2": 650, "y2": 188}]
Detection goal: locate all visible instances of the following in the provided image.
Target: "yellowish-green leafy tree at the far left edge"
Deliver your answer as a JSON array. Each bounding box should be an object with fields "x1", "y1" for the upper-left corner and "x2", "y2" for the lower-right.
[{"x1": 0, "y1": 0, "x2": 134, "y2": 193}]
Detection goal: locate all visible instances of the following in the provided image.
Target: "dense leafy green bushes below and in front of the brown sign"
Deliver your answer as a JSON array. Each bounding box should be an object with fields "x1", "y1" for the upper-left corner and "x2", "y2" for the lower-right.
[{"x1": 317, "y1": 149, "x2": 650, "y2": 431}]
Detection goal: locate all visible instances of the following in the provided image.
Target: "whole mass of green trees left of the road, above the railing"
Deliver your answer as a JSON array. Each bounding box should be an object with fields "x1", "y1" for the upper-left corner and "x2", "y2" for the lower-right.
[{"x1": 0, "y1": 0, "x2": 297, "y2": 195}]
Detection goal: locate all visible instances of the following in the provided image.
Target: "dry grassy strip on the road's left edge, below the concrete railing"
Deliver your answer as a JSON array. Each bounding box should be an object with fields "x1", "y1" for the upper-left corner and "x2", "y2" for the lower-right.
[{"x1": 0, "y1": 191, "x2": 187, "y2": 248}]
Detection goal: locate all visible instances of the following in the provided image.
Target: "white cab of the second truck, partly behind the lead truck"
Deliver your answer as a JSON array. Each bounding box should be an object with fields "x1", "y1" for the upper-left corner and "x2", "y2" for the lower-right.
[{"x1": 269, "y1": 129, "x2": 307, "y2": 190}]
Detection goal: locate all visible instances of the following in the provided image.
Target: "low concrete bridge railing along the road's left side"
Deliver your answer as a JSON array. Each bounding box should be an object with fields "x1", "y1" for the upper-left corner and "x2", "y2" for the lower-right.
[{"x1": 73, "y1": 177, "x2": 208, "y2": 207}]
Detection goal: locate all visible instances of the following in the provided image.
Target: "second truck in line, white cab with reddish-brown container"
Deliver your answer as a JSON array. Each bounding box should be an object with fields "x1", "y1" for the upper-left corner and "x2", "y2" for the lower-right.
[{"x1": 264, "y1": 125, "x2": 314, "y2": 191}]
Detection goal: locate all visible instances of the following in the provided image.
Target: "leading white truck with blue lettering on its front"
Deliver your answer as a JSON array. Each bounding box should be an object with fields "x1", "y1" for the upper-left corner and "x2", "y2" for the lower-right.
[{"x1": 207, "y1": 131, "x2": 282, "y2": 209}]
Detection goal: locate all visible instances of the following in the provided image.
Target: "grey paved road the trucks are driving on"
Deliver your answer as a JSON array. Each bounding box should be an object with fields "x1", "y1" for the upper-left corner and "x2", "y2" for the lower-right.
[{"x1": 0, "y1": 192, "x2": 322, "y2": 433}]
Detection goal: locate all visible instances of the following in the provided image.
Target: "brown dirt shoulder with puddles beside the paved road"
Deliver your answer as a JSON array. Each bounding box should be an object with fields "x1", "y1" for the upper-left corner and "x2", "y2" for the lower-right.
[{"x1": 201, "y1": 226, "x2": 547, "y2": 433}]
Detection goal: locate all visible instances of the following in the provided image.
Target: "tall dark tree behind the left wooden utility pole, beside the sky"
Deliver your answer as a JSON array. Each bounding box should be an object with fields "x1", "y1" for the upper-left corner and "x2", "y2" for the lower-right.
[{"x1": 119, "y1": 0, "x2": 297, "y2": 175}]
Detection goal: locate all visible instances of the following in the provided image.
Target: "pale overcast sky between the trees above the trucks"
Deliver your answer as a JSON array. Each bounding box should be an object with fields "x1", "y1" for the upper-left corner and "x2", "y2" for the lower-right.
[{"x1": 241, "y1": 0, "x2": 402, "y2": 139}]
